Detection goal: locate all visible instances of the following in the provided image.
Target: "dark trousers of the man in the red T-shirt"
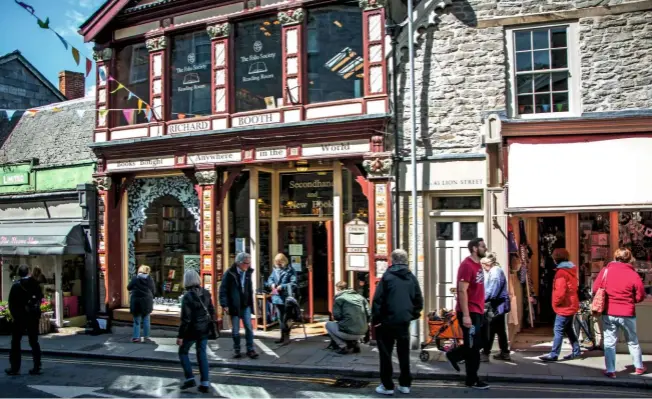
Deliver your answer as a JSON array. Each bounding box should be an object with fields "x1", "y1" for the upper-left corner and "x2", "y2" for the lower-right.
[{"x1": 448, "y1": 312, "x2": 484, "y2": 385}]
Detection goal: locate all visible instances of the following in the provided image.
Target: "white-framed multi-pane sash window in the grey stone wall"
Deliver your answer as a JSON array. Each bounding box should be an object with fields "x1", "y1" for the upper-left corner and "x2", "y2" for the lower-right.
[{"x1": 507, "y1": 24, "x2": 580, "y2": 118}]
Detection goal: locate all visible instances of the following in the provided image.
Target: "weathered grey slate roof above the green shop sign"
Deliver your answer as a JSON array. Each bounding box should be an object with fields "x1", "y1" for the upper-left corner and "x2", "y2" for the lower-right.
[{"x1": 0, "y1": 98, "x2": 96, "y2": 167}]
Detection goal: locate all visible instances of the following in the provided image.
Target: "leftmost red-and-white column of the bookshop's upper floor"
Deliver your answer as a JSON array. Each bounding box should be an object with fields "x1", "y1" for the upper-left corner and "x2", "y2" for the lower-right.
[{"x1": 93, "y1": 48, "x2": 113, "y2": 143}]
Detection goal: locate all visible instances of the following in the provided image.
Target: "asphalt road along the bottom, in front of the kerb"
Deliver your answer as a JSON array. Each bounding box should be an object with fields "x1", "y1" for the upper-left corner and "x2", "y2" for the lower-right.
[{"x1": 0, "y1": 355, "x2": 651, "y2": 399}]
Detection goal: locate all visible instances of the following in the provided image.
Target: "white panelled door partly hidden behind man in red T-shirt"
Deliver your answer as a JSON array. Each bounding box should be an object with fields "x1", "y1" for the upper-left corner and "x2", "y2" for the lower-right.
[{"x1": 428, "y1": 218, "x2": 484, "y2": 311}]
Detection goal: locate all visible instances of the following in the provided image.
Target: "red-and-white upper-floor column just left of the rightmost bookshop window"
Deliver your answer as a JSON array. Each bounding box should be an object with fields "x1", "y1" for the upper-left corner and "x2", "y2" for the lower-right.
[{"x1": 278, "y1": 8, "x2": 305, "y2": 107}]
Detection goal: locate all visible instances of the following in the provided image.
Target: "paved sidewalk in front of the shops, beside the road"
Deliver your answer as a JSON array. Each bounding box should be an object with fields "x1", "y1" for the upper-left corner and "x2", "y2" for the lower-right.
[{"x1": 0, "y1": 327, "x2": 652, "y2": 389}]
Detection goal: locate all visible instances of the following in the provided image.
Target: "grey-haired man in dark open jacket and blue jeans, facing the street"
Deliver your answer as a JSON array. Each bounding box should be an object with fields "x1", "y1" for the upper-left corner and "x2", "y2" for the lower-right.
[{"x1": 220, "y1": 252, "x2": 258, "y2": 359}]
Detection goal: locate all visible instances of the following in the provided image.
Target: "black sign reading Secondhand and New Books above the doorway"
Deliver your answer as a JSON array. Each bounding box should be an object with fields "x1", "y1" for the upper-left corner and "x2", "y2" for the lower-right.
[{"x1": 281, "y1": 172, "x2": 333, "y2": 217}]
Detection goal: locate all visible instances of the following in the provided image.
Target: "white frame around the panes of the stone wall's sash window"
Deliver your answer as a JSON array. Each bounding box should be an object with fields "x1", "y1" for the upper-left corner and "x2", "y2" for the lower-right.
[{"x1": 505, "y1": 21, "x2": 582, "y2": 119}]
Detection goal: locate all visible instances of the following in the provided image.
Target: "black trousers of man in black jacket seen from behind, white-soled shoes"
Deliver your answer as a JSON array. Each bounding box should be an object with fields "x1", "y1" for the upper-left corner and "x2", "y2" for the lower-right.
[{"x1": 376, "y1": 323, "x2": 412, "y2": 390}]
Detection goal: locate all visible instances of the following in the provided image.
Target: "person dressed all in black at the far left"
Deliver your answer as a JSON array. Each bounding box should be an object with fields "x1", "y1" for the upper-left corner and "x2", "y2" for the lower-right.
[{"x1": 5, "y1": 265, "x2": 43, "y2": 375}]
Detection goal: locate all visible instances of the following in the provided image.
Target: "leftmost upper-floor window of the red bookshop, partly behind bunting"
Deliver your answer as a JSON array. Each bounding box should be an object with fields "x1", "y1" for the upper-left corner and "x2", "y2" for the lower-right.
[{"x1": 110, "y1": 43, "x2": 150, "y2": 126}]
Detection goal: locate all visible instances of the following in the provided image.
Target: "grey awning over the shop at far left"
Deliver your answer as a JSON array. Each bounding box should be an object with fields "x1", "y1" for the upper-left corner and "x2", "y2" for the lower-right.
[{"x1": 0, "y1": 222, "x2": 88, "y2": 255}]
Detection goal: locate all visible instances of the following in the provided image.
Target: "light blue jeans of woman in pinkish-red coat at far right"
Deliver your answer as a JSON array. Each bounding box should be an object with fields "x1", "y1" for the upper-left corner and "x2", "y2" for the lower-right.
[{"x1": 602, "y1": 315, "x2": 643, "y2": 373}]
